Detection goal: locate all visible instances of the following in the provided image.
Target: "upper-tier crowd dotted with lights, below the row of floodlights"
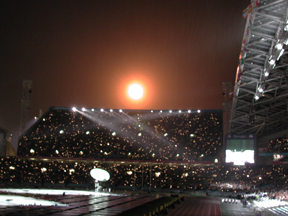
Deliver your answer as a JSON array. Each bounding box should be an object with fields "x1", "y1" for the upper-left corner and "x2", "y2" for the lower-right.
[{"x1": 18, "y1": 107, "x2": 223, "y2": 161}]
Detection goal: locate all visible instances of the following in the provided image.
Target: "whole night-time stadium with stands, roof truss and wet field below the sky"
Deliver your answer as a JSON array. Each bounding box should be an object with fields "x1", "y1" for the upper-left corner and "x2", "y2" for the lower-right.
[{"x1": 0, "y1": 0, "x2": 288, "y2": 216}]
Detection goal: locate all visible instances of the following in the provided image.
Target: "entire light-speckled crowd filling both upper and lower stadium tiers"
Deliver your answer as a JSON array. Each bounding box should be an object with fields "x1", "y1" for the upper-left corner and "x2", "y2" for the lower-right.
[{"x1": 6, "y1": 108, "x2": 288, "y2": 196}]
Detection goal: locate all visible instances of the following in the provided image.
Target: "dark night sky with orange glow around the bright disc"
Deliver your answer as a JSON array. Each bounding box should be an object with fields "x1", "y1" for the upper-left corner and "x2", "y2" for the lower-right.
[{"x1": 0, "y1": 0, "x2": 250, "y2": 148}]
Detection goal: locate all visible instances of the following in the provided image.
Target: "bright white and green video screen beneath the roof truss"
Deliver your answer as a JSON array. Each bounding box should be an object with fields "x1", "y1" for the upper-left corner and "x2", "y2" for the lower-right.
[{"x1": 225, "y1": 135, "x2": 256, "y2": 165}]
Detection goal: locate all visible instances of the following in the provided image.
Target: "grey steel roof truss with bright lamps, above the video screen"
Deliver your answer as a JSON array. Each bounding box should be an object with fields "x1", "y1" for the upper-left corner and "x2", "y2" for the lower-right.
[{"x1": 229, "y1": 0, "x2": 288, "y2": 141}]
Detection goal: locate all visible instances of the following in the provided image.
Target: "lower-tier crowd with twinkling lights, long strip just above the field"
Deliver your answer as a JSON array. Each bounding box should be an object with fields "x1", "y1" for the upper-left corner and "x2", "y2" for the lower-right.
[{"x1": 0, "y1": 157, "x2": 288, "y2": 191}]
